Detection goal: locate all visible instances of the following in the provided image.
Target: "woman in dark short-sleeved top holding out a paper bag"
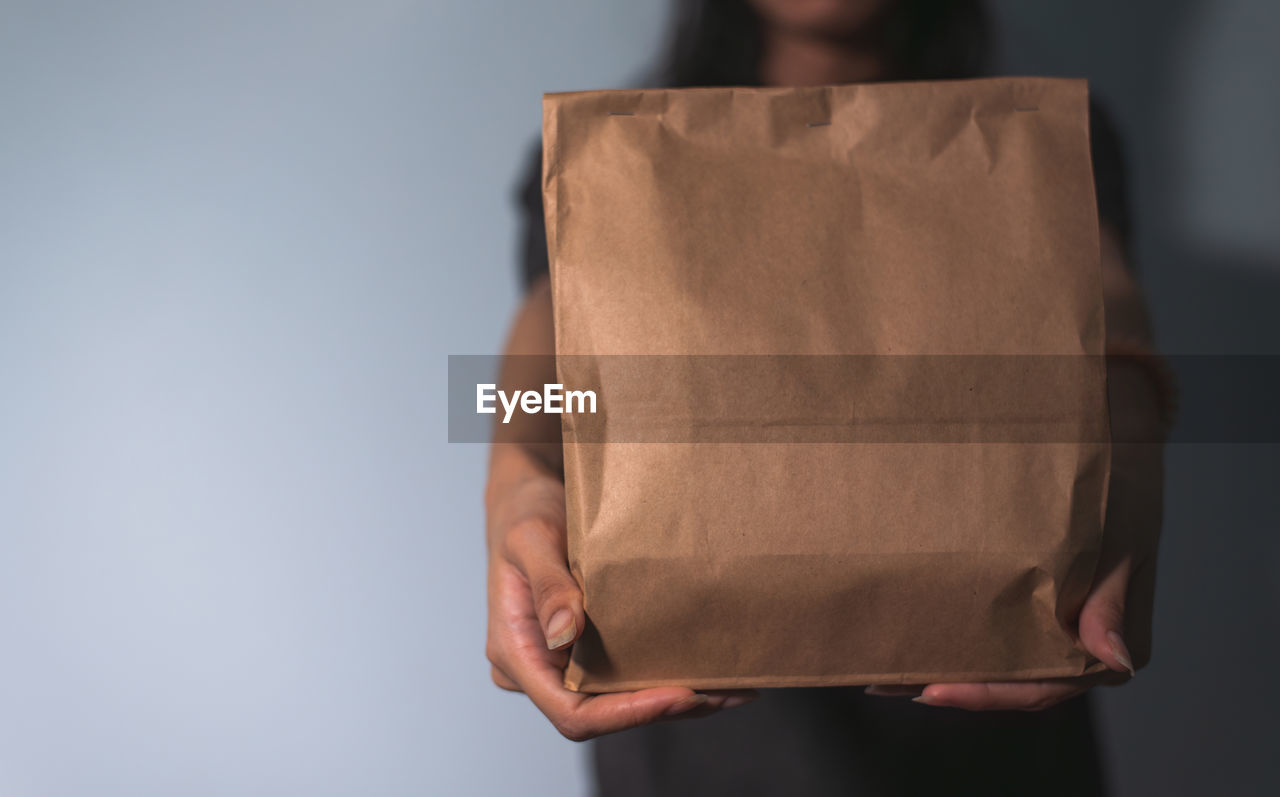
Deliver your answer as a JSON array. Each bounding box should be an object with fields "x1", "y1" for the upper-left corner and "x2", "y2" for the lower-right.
[{"x1": 486, "y1": 0, "x2": 1161, "y2": 796}]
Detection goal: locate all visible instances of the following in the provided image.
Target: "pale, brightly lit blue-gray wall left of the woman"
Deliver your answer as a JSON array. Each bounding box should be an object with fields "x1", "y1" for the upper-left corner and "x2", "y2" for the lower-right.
[{"x1": 0, "y1": 0, "x2": 663, "y2": 797}]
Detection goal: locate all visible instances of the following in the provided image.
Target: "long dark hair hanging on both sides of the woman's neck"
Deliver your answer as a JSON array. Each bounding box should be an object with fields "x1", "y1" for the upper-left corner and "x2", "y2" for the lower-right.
[{"x1": 654, "y1": 0, "x2": 991, "y2": 87}]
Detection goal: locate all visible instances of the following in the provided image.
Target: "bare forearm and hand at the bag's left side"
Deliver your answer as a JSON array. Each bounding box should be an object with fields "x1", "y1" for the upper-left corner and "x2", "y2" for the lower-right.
[{"x1": 485, "y1": 278, "x2": 755, "y2": 741}]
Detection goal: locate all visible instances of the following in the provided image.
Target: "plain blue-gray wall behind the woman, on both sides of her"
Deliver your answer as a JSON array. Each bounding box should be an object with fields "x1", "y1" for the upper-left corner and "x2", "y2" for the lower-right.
[{"x1": 0, "y1": 0, "x2": 1280, "y2": 797}]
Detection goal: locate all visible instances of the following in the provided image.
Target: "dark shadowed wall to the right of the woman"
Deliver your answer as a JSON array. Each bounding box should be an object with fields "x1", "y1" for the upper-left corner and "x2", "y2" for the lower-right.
[{"x1": 992, "y1": 0, "x2": 1280, "y2": 796}]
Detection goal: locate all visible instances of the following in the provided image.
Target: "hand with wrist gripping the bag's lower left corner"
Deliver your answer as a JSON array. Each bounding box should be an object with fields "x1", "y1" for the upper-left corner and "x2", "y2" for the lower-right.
[{"x1": 485, "y1": 452, "x2": 755, "y2": 741}]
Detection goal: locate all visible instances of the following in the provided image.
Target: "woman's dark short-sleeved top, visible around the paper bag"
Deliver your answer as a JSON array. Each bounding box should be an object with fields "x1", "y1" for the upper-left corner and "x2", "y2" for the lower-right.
[{"x1": 520, "y1": 95, "x2": 1132, "y2": 797}]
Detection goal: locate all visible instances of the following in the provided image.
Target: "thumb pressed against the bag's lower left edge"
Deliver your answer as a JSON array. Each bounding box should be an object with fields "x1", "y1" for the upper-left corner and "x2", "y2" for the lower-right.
[{"x1": 507, "y1": 521, "x2": 586, "y2": 650}]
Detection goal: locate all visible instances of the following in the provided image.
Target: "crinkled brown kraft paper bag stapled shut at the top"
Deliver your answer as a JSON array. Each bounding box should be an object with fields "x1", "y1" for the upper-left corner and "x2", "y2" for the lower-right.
[{"x1": 543, "y1": 78, "x2": 1111, "y2": 692}]
